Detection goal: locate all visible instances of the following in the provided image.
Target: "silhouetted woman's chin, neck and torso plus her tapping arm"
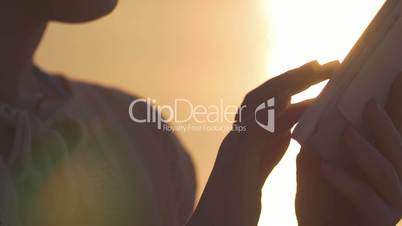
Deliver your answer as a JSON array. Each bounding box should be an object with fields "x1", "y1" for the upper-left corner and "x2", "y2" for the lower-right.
[{"x1": 0, "y1": 0, "x2": 400, "y2": 226}]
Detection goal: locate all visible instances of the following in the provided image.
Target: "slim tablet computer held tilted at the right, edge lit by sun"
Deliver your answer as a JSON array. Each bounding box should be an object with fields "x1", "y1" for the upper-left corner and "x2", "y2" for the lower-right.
[{"x1": 293, "y1": 0, "x2": 402, "y2": 160}]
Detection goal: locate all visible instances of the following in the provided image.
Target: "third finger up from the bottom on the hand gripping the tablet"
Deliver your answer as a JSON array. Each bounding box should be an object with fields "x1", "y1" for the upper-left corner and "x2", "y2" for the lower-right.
[{"x1": 364, "y1": 101, "x2": 402, "y2": 180}]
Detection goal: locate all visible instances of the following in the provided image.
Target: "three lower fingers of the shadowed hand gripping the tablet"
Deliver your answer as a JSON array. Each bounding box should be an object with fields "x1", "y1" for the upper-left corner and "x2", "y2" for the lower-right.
[{"x1": 322, "y1": 101, "x2": 402, "y2": 226}]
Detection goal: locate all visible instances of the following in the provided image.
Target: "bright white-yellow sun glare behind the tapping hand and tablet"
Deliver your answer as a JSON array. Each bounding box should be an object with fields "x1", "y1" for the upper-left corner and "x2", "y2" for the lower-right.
[{"x1": 259, "y1": 0, "x2": 385, "y2": 226}]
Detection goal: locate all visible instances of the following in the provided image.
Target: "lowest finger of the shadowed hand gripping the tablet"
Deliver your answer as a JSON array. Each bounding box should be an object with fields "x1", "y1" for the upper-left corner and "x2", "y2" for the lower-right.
[{"x1": 321, "y1": 163, "x2": 400, "y2": 226}]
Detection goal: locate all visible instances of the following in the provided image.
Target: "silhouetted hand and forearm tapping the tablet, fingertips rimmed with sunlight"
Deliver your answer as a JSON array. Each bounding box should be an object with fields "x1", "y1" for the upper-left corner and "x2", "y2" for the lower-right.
[{"x1": 188, "y1": 62, "x2": 339, "y2": 226}]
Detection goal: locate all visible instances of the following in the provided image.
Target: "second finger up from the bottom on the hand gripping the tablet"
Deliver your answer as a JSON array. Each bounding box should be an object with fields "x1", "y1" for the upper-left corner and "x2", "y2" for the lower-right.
[{"x1": 343, "y1": 127, "x2": 402, "y2": 207}]
